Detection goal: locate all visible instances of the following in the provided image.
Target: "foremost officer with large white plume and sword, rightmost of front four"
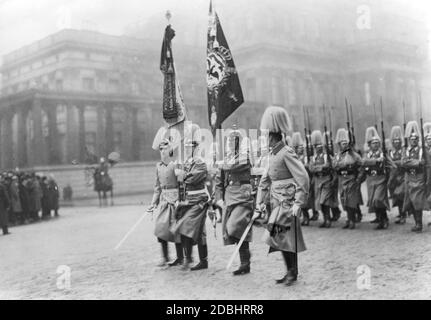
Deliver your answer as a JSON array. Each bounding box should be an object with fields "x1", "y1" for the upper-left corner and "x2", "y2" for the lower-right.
[{"x1": 257, "y1": 107, "x2": 310, "y2": 286}]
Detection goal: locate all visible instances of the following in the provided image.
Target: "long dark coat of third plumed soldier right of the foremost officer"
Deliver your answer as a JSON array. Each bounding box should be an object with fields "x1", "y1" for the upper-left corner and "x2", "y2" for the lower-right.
[{"x1": 362, "y1": 150, "x2": 390, "y2": 213}]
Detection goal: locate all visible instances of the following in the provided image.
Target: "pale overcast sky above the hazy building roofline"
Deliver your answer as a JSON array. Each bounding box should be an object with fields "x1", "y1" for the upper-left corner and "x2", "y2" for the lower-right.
[{"x1": 0, "y1": 0, "x2": 431, "y2": 63}]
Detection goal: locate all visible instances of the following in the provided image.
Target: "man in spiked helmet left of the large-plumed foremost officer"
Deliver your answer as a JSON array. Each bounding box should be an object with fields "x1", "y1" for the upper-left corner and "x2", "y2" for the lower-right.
[{"x1": 216, "y1": 126, "x2": 254, "y2": 276}]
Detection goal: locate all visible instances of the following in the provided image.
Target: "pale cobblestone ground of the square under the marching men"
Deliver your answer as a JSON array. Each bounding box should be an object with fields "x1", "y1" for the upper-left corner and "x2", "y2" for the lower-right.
[{"x1": 0, "y1": 197, "x2": 431, "y2": 299}]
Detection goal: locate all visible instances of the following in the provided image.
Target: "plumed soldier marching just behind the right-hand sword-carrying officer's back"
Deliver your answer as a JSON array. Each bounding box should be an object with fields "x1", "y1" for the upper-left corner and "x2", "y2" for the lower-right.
[{"x1": 309, "y1": 130, "x2": 337, "y2": 228}]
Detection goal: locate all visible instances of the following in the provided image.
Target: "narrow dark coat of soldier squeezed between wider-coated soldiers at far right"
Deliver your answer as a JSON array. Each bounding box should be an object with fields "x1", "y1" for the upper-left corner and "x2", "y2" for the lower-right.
[{"x1": 388, "y1": 149, "x2": 406, "y2": 209}]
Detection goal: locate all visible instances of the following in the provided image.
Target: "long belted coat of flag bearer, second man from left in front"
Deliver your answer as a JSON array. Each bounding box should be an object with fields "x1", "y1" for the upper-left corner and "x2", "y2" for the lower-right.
[{"x1": 171, "y1": 158, "x2": 209, "y2": 244}]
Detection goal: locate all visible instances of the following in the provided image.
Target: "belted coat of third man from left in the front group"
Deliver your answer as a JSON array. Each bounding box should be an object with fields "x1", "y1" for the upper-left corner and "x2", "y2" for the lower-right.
[{"x1": 215, "y1": 154, "x2": 254, "y2": 245}]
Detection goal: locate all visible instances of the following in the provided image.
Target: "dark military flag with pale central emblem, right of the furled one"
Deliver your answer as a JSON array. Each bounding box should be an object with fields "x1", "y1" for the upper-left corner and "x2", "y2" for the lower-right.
[{"x1": 207, "y1": 1, "x2": 244, "y2": 132}]
